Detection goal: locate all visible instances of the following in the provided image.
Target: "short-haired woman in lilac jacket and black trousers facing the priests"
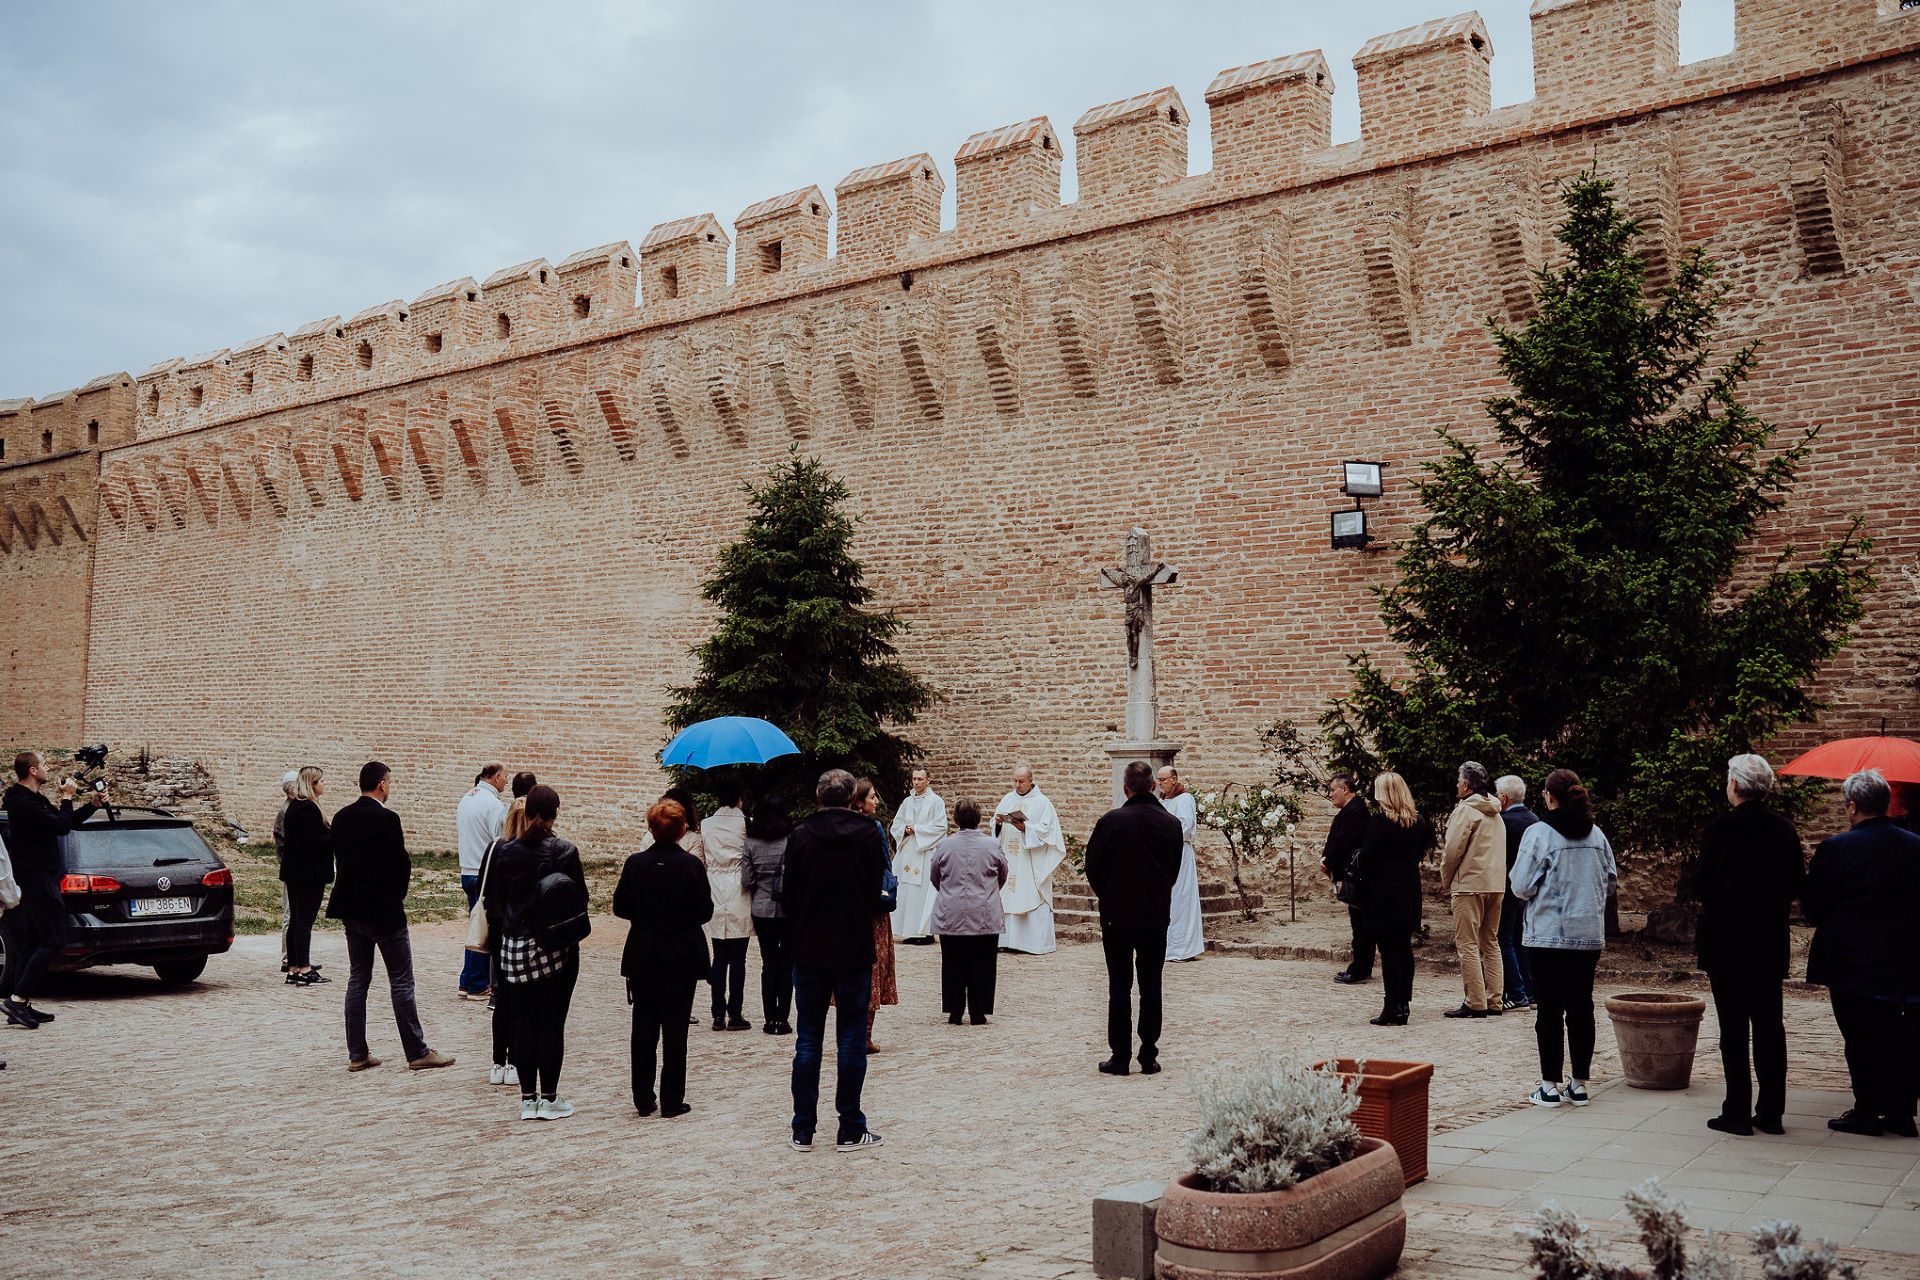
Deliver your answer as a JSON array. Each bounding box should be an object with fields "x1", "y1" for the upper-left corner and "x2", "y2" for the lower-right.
[{"x1": 927, "y1": 800, "x2": 1006, "y2": 1027}]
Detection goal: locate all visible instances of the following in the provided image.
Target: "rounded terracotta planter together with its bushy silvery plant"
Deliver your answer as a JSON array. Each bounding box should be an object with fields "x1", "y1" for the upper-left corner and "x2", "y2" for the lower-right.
[{"x1": 1154, "y1": 1052, "x2": 1407, "y2": 1280}]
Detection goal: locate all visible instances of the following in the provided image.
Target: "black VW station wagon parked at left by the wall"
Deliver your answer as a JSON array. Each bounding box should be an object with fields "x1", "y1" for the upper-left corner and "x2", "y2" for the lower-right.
[{"x1": 0, "y1": 806, "x2": 234, "y2": 990}]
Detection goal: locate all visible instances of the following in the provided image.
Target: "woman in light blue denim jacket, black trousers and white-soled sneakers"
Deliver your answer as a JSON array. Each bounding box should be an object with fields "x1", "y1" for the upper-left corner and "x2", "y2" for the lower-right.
[{"x1": 1511, "y1": 770, "x2": 1617, "y2": 1107}]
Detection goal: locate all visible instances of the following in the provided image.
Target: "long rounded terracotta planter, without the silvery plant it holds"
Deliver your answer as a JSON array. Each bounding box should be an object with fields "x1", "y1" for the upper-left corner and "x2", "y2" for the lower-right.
[{"x1": 1154, "y1": 1138, "x2": 1407, "y2": 1280}]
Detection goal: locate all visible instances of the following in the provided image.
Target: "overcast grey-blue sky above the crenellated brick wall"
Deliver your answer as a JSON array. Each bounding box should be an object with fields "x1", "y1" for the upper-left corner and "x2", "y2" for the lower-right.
[{"x1": 0, "y1": 0, "x2": 1734, "y2": 399}]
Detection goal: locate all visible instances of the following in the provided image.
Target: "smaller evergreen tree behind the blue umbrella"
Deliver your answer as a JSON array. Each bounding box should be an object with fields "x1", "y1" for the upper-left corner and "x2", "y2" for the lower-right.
[{"x1": 666, "y1": 447, "x2": 937, "y2": 802}]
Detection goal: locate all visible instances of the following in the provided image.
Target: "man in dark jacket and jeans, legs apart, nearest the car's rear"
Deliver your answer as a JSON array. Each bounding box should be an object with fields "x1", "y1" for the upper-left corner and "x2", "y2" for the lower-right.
[{"x1": 326, "y1": 760, "x2": 453, "y2": 1071}]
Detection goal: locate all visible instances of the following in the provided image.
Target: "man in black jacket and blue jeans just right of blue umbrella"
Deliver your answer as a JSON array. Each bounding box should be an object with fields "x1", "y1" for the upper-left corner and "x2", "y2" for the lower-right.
[{"x1": 781, "y1": 770, "x2": 887, "y2": 1151}]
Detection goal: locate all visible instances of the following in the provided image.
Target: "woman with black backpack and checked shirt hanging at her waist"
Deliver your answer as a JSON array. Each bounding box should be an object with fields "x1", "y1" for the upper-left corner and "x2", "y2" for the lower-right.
[{"x1": 490, "y1": 787, "x2": 589, "y2": 1121}]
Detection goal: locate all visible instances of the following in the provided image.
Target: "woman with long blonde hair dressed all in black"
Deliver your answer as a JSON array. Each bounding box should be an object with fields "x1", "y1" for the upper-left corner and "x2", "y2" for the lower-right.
[{"x1": 1348, "y1": 773, "x2": 1434, "y2": 1027}]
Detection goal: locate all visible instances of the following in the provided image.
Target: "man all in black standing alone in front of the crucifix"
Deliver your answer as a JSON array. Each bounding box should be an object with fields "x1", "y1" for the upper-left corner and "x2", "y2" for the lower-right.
[{"x1": 1087, "y1": 760, "x2": 1183, "y2": 1075}]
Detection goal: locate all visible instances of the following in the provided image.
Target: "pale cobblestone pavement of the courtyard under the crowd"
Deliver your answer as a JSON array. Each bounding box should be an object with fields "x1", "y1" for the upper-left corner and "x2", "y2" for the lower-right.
[{"x1": 0, "y1": 919, "x2": 1914, "y2": 1280}]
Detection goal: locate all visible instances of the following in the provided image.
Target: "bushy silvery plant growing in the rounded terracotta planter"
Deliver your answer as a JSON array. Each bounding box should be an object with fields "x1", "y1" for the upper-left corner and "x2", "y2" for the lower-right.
[{"x1": 1187, "y1": 1050, "x2": 1359, "y2": 1192}]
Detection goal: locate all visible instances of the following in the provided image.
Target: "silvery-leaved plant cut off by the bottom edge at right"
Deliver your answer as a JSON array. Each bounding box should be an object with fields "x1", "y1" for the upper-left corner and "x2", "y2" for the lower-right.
[{"x1": 1519, "y1": 1178, "x2": 1859, "y2": 1280}]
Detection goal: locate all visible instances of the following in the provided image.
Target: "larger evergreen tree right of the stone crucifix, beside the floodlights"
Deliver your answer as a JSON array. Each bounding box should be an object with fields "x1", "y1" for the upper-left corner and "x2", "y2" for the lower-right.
[{"x1": 1321, "y1": 171, "x2": 1870, "y2": 850}]
